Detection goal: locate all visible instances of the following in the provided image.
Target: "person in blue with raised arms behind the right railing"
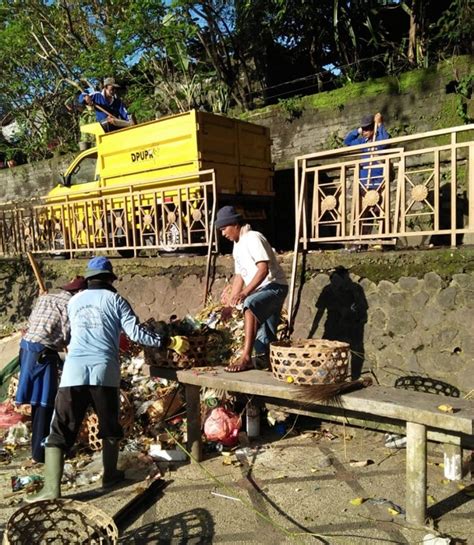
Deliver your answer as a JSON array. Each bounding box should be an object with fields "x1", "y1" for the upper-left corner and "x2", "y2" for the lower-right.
[{"x1": 344, "y1": 113, "x2": 390, "y2": 190}]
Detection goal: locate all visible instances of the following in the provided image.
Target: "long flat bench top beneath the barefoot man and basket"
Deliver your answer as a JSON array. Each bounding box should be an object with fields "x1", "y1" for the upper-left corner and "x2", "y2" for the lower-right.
[{"x1": 177, "y1": 368, "x2": 474, "y2": 435}]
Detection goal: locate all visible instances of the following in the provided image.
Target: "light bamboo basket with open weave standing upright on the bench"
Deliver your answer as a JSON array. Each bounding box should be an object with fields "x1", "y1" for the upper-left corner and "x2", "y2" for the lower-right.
[{"x1": 270, "y1": 339, "x2": 350, "y2": 384}]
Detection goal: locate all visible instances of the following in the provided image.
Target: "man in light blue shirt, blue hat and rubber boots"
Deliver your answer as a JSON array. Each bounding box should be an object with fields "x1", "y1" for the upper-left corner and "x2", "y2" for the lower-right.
[{"x1": 26, "y1": 256, "x2": 189, "y2": 502}]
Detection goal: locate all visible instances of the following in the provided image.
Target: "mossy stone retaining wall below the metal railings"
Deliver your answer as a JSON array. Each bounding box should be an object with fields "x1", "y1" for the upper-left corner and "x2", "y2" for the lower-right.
[{"x1": 0, "y1": 249, "x2": 474, "y2": 393}]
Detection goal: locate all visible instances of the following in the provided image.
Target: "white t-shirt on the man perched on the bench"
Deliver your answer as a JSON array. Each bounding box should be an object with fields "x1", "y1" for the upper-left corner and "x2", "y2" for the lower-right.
[{"x1": 232, "y1": 230, "x2": 287, "y2": 289}]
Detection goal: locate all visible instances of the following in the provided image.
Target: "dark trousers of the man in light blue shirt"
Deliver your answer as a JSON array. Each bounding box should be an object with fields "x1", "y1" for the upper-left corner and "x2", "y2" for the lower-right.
[{"x1": 46, "y1": 386, "x2": 123, "y2": 451}]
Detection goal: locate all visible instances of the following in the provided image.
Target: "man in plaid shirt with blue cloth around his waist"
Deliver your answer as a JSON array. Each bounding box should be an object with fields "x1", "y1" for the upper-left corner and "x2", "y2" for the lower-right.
[{"x1": 16, "y1": 276, "x2": 87, "y2": 463}]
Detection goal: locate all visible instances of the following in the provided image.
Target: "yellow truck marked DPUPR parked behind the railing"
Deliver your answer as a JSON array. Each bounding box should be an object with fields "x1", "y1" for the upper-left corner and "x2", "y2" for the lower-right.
[{"x1": 33, "y1": 110, "x2": 274, "y2": 255}]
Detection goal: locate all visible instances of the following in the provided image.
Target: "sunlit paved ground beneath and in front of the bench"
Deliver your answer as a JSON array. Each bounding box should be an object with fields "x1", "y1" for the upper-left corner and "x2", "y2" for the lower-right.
[{"x1": 0, "y1": 417, "x2": 474, "y2": 545}]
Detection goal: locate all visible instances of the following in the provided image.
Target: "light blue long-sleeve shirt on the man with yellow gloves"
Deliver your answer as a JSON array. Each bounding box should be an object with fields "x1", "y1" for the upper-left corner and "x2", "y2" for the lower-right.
[{"x1": 59, "y1": 287, "x2": 165, "y2": 388}]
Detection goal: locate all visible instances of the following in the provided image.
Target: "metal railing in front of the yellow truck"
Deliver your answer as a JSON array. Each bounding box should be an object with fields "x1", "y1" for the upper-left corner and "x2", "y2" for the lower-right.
[{"x1": 0, "y1": 170, "x2": 216, "y2": 256}]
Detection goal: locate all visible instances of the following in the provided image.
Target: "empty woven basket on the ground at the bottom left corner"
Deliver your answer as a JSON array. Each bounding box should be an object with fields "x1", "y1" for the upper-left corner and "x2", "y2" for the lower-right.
[{"x1": 3, "y1": 499, "x2": 118, "y2": 545}]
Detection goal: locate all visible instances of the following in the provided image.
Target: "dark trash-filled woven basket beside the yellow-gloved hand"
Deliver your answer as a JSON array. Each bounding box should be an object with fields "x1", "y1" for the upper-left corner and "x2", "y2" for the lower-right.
[{"x1": 143, "y1": 335, "x2": 208, "y2": 369}]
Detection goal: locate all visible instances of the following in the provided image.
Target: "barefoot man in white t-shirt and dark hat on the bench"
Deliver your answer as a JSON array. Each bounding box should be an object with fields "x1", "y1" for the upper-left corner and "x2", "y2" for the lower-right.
[{"x1": 215, "y1": 206, "x2": 288, "y2": 373}]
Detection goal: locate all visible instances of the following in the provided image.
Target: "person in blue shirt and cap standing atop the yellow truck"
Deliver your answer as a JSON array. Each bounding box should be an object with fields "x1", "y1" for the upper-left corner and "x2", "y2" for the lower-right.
[{"x1": 79, "y1": 78, "x2": 133, "y2": 132}]
